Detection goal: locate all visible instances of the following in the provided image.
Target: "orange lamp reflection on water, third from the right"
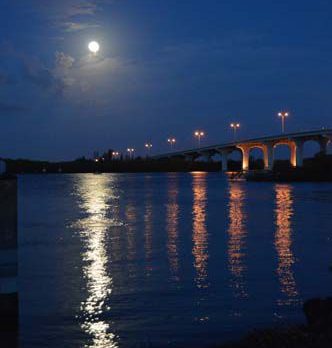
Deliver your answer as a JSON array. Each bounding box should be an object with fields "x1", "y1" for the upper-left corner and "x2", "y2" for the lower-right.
[{"x1": 192, "y1": 172, "x2": 209, "y2": 288}]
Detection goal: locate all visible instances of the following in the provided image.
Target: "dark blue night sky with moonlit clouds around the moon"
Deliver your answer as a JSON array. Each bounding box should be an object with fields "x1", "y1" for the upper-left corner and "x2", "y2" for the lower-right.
[{"x1": 0, "y1": 0, "x2": 332, "y2": 160}]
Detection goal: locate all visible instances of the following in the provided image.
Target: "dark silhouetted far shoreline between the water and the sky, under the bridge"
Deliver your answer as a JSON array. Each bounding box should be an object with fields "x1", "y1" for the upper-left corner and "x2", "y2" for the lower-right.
[{"x1": 5, "y1": 155, "x2": 332, "y2": 182}]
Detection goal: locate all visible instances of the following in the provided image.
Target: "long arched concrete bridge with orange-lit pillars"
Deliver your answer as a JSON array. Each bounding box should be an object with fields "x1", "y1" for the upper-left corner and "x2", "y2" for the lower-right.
[{"x1": 153, "y1": 128, "x2": 332, "y2": 171}]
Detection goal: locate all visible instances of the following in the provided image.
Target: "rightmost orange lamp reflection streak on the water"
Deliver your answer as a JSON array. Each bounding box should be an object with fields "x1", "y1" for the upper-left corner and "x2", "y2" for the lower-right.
[{"x1": 274, "y1": 184, "x2": 298, "y2": 305}]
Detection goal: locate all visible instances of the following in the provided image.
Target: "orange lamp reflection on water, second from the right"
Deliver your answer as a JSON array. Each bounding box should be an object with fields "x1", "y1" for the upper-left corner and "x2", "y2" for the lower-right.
[{"x1": 228, "y1": 182, "x2": 248, "y2": 298}]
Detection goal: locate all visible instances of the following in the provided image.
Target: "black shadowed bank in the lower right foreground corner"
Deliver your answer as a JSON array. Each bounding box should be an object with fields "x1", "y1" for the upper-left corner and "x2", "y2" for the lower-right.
[{"x1": 221, "y1": 298, "x2": 332, "y2": 348}]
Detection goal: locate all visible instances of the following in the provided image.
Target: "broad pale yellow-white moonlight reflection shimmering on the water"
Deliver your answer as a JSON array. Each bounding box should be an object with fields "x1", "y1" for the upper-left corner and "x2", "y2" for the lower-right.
[{"x1": 76, "y1": 175, "x2": 119, "y2": 348}]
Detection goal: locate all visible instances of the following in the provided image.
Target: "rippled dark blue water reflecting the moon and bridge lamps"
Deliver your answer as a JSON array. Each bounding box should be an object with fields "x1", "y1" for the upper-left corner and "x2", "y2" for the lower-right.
[{"x1": 19, "y1": 173, "x2": 332, "y2": 348}]
